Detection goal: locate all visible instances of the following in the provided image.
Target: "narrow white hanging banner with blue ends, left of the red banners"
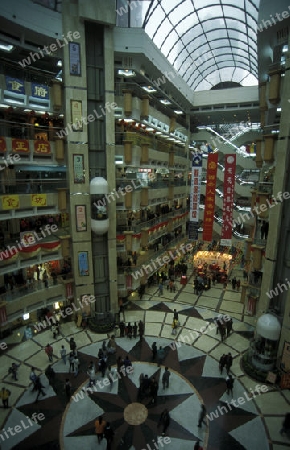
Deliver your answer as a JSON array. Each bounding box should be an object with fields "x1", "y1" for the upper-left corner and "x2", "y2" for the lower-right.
[{"x1": 188, "y1": 154, "x2": 202, "y2": 241}]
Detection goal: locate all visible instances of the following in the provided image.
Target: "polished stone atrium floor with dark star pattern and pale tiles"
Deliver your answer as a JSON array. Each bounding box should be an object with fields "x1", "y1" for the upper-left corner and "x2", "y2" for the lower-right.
[{"x1": 0, "y1": 268, "x2": 290, "y2": 450}]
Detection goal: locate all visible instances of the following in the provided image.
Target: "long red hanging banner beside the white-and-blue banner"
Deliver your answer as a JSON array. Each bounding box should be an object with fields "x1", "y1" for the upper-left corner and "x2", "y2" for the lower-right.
[{"x1": 202, "y1": 153, "x2": 218, "y2": 241}]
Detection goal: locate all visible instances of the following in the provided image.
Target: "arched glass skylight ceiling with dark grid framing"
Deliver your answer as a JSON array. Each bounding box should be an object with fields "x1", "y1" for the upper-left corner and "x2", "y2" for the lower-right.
[{"x1": 144, "y1": 0, "x2": 260, "y2": 91}]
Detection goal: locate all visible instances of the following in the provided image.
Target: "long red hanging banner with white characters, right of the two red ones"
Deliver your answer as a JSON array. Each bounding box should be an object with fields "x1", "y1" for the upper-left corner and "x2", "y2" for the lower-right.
[{"x1": 221, "y1": 155, "x2": 236, "y2": 245}]
